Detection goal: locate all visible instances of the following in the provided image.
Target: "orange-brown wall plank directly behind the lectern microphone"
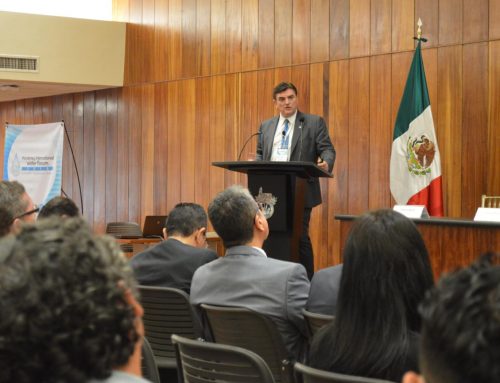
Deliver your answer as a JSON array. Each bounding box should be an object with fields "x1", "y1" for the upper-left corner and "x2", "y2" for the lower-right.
[{"x1": 240, "y1": 71, "x2": 264, "y2": 164}]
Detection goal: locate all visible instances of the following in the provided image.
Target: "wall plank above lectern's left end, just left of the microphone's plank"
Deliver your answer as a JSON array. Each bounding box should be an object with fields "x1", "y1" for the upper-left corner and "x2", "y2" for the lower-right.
[{"x1": 224, "y1": 74, "x2": 243, "y2": 187}]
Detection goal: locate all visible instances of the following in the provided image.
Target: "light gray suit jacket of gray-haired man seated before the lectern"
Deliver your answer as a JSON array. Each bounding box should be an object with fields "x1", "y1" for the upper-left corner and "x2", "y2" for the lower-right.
[{"x1": 190, "y1": 246, "x2": 309, "y2": 359}]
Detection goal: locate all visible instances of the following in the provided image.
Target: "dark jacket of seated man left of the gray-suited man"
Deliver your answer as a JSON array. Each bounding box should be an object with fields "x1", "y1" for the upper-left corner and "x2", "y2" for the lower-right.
[{"x1": 130, "y1": 238, "x2": 217, "y2": 294}]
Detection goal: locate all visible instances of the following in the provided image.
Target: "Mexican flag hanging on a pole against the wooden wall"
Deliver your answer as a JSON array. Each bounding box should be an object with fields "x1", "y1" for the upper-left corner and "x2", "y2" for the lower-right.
[{"x1": 390, "y1": 40, "x2": 443, "y2": 217}]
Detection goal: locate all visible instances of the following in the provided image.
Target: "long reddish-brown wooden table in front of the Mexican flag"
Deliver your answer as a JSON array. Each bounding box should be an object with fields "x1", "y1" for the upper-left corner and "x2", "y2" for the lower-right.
[{"x1": 335, "y1": 214, "x2": 500, "y2": 278}]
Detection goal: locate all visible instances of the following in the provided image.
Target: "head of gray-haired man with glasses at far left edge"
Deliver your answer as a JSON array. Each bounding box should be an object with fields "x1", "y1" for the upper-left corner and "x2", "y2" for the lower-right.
[{"x1": 0, "y1": 181, "x2": 39, "y2": 233}]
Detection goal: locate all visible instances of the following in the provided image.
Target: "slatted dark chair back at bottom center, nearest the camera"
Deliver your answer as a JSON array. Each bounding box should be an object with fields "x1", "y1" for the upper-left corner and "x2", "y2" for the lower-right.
[{"x1": 172, "y1": 335, "x2": 274, "y2": 383}]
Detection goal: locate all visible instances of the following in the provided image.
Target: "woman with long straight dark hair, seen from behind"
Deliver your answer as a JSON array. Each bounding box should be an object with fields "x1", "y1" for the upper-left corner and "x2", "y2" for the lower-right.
[{"x1": 309, "y1": 210, "x2": 433, "y2": 382}]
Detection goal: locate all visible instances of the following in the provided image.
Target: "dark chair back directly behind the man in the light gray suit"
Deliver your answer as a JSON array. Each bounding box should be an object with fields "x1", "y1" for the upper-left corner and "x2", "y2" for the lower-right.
[{"x1": 201, "y1": 304, "x2": 294, "y2": 382}]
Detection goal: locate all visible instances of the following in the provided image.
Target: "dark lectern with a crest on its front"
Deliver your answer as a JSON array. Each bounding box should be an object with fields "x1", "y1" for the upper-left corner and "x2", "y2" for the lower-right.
[{"x1": 212, "y1": 161, "x2": 333, "y2": 262}]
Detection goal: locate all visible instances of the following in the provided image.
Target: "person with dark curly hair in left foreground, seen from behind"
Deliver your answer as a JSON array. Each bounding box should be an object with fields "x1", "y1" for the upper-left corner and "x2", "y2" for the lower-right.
[{"x1": 0, "y1": 218, "x2": 150, "y2": 383}]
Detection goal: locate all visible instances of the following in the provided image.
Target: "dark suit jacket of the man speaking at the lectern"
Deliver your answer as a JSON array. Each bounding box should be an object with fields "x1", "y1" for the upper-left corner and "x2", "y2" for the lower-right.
[{"x1": 256, "y1": 111, "x2": 335, "y2": 208}]
